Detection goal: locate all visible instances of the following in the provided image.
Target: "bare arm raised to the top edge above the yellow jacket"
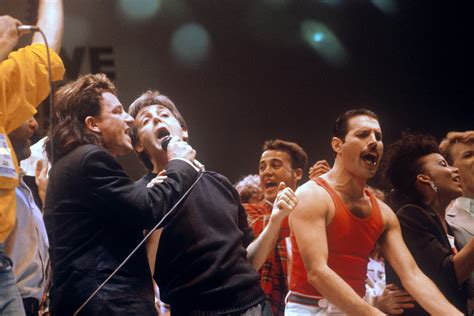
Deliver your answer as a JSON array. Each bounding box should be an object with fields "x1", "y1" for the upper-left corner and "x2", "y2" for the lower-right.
[{"x1": 32, "y1": 0, "x2": 64, "y2": 52}]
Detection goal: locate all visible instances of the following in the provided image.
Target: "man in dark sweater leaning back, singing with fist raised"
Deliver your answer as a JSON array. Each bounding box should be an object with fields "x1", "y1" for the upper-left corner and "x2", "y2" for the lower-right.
[{"x1": 129, "y1": 91, "x2": 296, "y2": 315}]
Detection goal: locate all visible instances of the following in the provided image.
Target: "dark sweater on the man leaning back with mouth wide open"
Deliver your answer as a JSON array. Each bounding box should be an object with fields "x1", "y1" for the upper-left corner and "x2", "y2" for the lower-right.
[{"x1": 136, "y1": 171, "x2": 265, "y2": 315}]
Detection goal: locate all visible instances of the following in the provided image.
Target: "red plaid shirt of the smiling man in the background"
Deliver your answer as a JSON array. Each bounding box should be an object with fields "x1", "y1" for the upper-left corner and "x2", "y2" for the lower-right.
[{"x1": 244, "y1": 202, "x2": 290, "y2": 316}]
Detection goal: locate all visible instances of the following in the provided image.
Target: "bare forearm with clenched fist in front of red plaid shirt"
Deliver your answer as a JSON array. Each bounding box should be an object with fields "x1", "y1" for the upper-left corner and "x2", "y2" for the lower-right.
[{"x1": 247, "y1": 182, "x2": 298, "y2": 270}]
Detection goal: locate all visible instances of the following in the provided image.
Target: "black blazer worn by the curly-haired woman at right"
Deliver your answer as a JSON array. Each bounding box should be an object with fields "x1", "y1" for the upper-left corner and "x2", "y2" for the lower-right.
[{"x1": 386, "y1": 204, "x2": 467, "y2": 315}]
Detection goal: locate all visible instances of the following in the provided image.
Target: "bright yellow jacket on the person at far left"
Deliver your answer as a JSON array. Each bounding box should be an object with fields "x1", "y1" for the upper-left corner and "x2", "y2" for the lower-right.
[{"x1": 0, "y1": 43, "x2": 64, "y2": 243}]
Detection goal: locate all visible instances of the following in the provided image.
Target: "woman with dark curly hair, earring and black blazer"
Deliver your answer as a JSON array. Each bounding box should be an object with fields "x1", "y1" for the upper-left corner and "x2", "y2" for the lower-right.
[{"x1": 384, "y1": 132, "x2": 474, "y2": 315}]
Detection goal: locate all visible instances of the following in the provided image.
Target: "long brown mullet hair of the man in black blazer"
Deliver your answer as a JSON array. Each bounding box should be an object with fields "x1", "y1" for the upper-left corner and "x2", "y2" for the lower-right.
[{"x1": 45, "y1": 74, "x2": 117, "y2": 163}]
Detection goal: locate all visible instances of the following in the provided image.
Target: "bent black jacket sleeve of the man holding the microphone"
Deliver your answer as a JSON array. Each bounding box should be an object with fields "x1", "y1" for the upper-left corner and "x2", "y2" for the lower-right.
[{"x1": 81, "y1": 148, "x2": 198, "y2": 229}]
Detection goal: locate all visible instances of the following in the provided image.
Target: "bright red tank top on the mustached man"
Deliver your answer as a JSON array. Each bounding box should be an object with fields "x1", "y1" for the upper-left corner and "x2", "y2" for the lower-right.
[{"x1": 290, "y1": 178, "x2": 383, "y2": 297}]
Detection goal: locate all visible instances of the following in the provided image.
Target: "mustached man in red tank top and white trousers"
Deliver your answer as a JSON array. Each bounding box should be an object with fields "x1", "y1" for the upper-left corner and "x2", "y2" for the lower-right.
[{"x1": 285, "y1": 109, "x2": 462, "y2": 315}]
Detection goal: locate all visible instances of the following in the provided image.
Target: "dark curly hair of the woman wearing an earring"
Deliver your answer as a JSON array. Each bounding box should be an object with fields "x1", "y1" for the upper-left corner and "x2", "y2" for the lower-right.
[{"x1": 382, "y1": 132, "x2": 439, "y2": 206}]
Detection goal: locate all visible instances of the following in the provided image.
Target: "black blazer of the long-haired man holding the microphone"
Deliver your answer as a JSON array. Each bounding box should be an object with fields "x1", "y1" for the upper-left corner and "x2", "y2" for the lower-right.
[{"x1": 44, "y1": 145, "x2": 197, "y2": 315}]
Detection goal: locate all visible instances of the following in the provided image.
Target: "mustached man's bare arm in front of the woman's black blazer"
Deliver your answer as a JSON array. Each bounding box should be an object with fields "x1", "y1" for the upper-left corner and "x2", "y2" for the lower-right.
[{"x1": 380, "y1": 203, "x2": 462, "y2": 315}]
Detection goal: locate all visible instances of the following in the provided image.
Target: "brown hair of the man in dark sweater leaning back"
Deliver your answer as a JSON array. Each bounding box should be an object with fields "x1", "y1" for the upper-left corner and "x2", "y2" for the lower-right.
[{"x1": 128, "y1": 90, "x2": 188, "y2": 170}]
